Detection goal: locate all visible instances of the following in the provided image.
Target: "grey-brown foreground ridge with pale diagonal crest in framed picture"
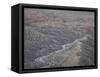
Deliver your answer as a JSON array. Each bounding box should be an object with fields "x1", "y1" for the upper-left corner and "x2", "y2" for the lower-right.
[{"x1": 24, "y1": 35, "x2": 94, "y2": 68}]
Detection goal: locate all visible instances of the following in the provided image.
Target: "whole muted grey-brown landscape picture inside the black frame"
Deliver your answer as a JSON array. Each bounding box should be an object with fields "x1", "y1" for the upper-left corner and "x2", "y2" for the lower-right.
[{"x1": 24, "y1": 8, "x2": 95, "y2": 69}]
